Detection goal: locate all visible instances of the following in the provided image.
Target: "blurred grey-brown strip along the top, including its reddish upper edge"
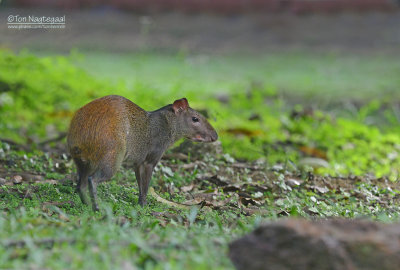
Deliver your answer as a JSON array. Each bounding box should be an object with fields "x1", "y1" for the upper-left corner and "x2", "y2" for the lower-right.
[{"x1": 1, "y1": 0, "x2": 400, "y2": 54}]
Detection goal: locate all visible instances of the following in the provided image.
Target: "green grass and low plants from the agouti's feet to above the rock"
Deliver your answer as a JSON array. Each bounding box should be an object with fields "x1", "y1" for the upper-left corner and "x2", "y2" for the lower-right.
[{"x1": 0, "y1": 149, "x2": 400, "y2": 269}]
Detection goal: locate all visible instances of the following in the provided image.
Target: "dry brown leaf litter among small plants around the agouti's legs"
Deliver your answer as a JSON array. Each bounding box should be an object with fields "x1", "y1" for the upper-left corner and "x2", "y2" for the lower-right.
[{"x1": 0, "y1": 139, "x2": 400, "y2": 226}]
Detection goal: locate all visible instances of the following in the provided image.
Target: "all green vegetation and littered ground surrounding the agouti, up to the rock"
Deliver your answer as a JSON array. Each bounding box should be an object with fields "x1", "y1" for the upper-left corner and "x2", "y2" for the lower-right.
[{"x1": 0, "y1": 50, "x2": 400, "y2": 269}]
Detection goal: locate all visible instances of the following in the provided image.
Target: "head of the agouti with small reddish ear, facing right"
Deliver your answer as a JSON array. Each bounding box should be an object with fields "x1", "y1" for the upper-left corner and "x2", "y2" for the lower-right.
[{"x1": 172, "y1": 98, "x2": 218, "y2": 142}]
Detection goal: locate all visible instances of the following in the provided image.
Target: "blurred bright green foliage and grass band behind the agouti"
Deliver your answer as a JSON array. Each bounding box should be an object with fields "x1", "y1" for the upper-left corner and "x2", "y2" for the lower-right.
[{"x1": 0, "y1": 51, "x2": 400, "y2": 180}]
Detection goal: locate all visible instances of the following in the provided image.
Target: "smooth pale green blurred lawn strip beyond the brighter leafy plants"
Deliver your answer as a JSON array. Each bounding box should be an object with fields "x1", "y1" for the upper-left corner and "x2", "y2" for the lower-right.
[{"x1": 73, "y1": 52, "x2": 400, "y2": 105}]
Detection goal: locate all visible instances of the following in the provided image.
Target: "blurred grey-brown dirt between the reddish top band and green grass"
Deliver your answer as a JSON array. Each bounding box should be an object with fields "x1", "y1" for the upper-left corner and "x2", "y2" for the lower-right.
[{"x1": 0, "y1": 8, "x2": 400, "y2": 54}]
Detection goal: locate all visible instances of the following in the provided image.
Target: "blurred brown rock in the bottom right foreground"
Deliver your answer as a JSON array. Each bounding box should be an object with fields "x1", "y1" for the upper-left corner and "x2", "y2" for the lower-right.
[{"x1": 229, "y1": 219, "x2": 400, "y2": 270}]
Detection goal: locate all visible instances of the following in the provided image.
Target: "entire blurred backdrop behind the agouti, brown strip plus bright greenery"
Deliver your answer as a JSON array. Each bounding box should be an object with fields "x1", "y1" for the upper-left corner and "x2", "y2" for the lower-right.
[{"x1": 0, "y1": 0, "x2": 400, "y2": 179}]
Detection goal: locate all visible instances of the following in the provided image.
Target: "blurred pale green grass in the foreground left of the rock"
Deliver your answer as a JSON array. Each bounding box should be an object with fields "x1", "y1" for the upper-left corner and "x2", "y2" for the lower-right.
[{"x1": 0, "y1": 201, "x2": 244, "y2": 269}]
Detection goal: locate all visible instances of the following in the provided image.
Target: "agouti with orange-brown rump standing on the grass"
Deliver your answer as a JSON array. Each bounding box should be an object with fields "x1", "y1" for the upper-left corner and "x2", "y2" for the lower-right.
[{"x1": 67, "y1": 95, "x2": 218, "y2": 211}]
